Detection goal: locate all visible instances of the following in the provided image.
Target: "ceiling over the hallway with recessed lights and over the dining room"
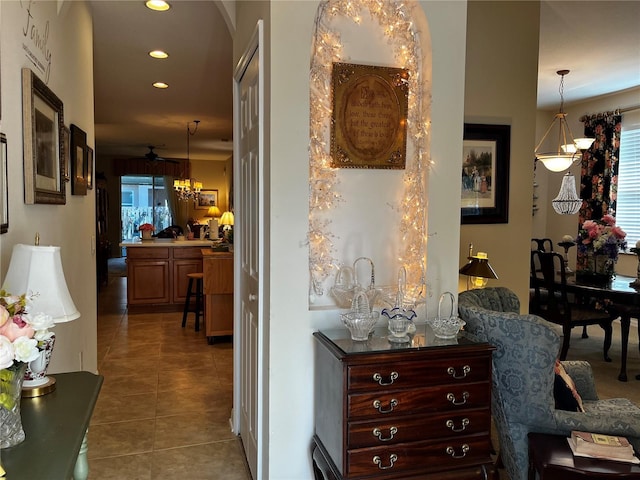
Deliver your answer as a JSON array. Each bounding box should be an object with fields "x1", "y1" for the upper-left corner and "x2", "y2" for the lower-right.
[{"x1": 90, "y1": 0, "x2": 640, "y2": 160}]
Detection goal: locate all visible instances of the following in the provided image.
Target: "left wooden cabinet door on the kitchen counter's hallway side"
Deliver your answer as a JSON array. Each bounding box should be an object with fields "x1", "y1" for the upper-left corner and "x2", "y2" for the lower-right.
[{"x1": 127, "y1": 260, "x2": 171, "y2": 305}]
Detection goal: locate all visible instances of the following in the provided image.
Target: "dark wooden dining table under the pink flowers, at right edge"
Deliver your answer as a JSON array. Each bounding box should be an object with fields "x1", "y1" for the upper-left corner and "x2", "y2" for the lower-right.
[{"x1": 567, "y1": 275, "x2": 640, "y2": 382}]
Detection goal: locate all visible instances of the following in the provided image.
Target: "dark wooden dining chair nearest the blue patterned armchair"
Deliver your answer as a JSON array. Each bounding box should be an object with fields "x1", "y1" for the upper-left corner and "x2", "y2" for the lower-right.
[{"x1": 529, "y1": 250, "x2": 617, "y2": 362}]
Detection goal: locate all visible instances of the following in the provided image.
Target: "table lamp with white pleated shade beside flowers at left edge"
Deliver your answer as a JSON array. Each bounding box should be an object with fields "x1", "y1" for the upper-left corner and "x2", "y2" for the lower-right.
[{"x1": 2, "y1": 244, "x2": 80, "y2": 397}]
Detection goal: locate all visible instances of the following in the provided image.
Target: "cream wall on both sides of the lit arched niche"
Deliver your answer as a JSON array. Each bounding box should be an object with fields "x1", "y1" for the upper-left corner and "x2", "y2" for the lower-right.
[{"x1": 234, "y1": 1, "x2": 466, "y2": 480}]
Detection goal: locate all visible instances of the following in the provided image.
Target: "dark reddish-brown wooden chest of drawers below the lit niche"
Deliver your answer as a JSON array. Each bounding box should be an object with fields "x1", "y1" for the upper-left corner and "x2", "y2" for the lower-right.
[{"x1": 313, "y1": 325, "x2": 493, "y2": 480}]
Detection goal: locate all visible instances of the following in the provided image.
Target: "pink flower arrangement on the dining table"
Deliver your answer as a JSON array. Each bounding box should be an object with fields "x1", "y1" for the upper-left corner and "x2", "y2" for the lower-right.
[{"x1": 576, "y1": 215, "x2": 627, "y2": 260}]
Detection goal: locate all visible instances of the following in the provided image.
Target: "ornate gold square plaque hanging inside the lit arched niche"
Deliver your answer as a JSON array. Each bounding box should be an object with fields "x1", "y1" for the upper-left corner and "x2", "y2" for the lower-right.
[{"x1": 331, "y1": 62, "x2": 409, "y2": 169}]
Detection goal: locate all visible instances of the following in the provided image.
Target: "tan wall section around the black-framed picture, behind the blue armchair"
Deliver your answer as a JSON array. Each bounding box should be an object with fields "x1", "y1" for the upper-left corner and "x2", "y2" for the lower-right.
[{"x1": 459, "y1": 1, "x2": 540, "y2": 311}]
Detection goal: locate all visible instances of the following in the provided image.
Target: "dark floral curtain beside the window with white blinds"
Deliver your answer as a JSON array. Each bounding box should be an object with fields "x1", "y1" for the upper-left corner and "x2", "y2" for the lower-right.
[{"x1": 576, "y1": 112, "x2": 622, "y2": 270}]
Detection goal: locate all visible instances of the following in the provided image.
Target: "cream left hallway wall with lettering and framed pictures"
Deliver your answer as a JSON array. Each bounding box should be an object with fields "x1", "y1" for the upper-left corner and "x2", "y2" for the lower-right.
[{"x1": 0, "y1": 1, "x2": 97, "y2": 373}]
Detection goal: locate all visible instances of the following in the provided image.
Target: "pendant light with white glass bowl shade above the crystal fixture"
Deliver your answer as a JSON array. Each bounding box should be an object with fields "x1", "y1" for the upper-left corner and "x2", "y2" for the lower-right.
[{"x1": 535, "y1": 70, "x2": 594, "y2": 171}]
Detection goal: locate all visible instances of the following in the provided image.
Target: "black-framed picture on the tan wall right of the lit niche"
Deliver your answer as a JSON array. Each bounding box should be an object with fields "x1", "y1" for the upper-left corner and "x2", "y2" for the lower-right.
[{"x1": 461, "y1": 123, "x2": 511, "y2": 225}]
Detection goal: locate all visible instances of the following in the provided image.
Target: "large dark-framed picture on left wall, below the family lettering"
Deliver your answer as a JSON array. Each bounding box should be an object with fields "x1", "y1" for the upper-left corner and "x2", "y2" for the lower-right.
[{"x1": 22, "y1": 68, "x2": 66, "y2": 204}]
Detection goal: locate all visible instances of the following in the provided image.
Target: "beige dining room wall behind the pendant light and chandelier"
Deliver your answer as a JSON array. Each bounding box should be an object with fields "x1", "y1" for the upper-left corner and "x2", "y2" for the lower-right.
[{"x1": 535, "y1": 85, "x2": 640, "y2": 277}]
